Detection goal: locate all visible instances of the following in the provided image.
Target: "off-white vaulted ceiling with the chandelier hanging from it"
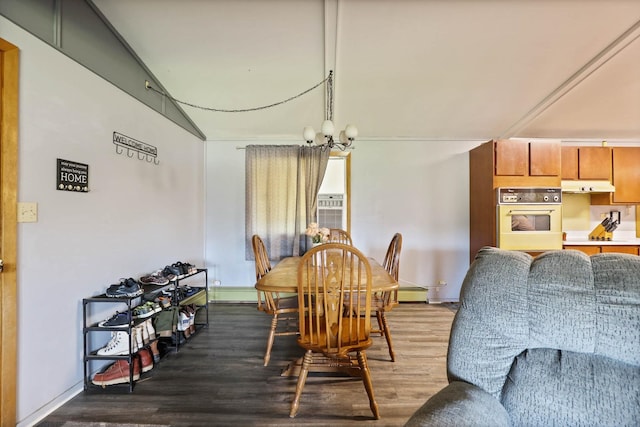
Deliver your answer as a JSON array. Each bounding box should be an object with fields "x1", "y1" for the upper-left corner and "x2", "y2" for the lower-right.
[{"x1": 93, "y1": 0, "x2": 640, "y2": 140}]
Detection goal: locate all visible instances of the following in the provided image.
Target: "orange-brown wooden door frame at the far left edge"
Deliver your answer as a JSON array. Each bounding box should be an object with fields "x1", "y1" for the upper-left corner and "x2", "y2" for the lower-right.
[{"x1": 0, "y1": 39, "x2": 20, "y2": 426}]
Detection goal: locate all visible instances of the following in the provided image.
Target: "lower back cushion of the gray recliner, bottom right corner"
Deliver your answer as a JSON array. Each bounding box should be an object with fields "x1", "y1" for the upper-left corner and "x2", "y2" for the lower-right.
[{"x1": 502, "y1": 348, "x2": 640, "y2": 427}]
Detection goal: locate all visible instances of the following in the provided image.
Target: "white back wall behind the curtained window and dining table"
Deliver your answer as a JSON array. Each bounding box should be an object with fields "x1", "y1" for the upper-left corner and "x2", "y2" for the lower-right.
[{"x1": 206, "y1": 140, "x2": 482, "y2": 301}]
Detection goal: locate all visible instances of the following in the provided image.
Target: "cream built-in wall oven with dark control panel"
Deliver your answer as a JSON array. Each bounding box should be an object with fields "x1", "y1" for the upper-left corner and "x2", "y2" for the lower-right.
[{"x1": 496, "y1": 187, "x2": 562, "y2": 252}]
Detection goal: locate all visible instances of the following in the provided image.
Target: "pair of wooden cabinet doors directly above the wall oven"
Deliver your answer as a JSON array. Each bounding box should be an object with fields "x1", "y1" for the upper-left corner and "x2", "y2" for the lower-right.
[{"x1": 494, "y1": 139, "x2": 561, "y2": 176}]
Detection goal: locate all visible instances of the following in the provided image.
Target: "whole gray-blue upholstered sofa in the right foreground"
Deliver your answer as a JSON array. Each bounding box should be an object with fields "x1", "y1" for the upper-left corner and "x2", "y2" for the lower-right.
[{"x1": 406, "y1": 247, "x2": 640, "y2": 427}]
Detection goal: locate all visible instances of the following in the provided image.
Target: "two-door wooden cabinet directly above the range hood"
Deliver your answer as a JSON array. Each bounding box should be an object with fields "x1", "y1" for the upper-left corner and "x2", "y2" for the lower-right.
[{"x1": 561, "y1": 146, "x2": 612, "y2": 181}]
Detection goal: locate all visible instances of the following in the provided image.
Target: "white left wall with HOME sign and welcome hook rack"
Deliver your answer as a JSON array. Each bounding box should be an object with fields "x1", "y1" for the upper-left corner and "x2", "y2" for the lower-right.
[{"x1": 0, "y1": 17, "x2": 204, "y2": 425}]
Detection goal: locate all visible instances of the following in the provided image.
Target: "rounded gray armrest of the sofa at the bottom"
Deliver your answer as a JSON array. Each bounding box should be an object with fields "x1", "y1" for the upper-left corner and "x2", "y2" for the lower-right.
[{"x1": 405, "y1": 381, "x2": 510, "y2": 427}]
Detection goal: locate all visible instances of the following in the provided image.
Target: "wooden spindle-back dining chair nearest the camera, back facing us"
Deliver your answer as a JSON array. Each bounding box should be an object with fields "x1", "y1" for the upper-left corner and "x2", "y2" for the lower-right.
[{"x1": 289, "y1": 243, "x2": 380, "y2": 419}]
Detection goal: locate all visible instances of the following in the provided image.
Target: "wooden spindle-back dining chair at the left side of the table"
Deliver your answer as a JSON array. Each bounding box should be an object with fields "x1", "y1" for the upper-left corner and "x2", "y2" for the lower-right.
[{"x1": 251, "y1": 235, "x2": 298, "y2": 366}]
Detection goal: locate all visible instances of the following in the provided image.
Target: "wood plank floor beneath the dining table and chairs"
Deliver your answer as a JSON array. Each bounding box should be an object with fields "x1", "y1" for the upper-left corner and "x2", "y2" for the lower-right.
[{"x1": 38, "y1": 303, "x2": 455, "y2": 427}]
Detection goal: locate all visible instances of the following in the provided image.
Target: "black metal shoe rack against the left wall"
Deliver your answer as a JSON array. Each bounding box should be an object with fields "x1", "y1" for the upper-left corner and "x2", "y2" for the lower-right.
[{"x1": 82, "y1": 268, "x2": 209, "y2": 392}]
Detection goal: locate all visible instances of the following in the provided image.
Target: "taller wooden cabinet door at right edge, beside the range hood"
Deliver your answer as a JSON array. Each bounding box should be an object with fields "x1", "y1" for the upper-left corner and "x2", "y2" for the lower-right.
[{"x1": 612, "y1": 147, "x2": 640, "y2": 204}]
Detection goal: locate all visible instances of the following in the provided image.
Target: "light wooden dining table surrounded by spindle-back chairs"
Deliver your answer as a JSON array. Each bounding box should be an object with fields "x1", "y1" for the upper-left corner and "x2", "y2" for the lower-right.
[{"x1": 255, "y1": 256, "x2": 400, "y2": 376}]
